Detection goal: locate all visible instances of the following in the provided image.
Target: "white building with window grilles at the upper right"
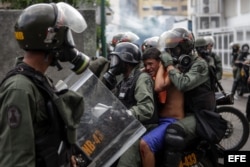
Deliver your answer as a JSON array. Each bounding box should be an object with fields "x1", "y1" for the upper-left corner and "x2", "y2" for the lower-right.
[{"x1": 188, "y1": 0, "x2": 250, "y2": 71}]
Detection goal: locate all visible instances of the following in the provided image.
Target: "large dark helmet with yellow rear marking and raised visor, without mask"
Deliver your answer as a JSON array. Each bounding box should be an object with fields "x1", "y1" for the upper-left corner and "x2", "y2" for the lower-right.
[{"x1": 15, "y1": 2, "x2": 87, "y2": 51}]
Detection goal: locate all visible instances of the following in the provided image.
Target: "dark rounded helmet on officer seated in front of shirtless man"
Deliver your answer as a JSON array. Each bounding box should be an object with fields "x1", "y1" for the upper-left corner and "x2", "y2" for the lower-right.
[{"x1": 110, "y1": 42, "x2": 141, "y2": 64}]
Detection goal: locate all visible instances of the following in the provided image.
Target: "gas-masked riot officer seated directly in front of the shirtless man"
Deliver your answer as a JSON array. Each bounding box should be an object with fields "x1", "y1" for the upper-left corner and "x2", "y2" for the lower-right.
[{"x1": 104, "y1": 42, "x2": 158, "y2": 167}]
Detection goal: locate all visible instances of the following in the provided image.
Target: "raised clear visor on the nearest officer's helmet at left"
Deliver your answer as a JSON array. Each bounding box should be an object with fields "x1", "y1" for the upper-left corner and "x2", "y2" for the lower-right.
[{"x1": 55, "y1": 2, "x2": 87, "y2": 33}]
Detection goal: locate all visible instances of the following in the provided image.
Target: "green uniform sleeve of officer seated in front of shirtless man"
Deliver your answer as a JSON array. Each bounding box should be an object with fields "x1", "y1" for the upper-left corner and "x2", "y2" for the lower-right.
[{"x1": 130, "y1": 73, "x2": 154, "y2": 122}]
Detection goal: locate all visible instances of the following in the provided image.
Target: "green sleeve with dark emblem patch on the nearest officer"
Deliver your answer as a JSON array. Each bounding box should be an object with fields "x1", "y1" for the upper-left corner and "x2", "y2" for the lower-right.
[{"x1": 0, "y1": 89, "x2": 35, "y2": 167}]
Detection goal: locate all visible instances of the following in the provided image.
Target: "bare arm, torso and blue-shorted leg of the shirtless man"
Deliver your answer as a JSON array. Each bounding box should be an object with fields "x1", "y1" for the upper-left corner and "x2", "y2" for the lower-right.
[{"x1": 140, "y1": 52, "x2": 184, "y2": 167}]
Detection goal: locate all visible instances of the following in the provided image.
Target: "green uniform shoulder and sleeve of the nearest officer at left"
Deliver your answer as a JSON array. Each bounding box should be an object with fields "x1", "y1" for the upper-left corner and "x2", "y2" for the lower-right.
[{"x1": 0, "y1": 75, "x2": 38, "y2": 167}]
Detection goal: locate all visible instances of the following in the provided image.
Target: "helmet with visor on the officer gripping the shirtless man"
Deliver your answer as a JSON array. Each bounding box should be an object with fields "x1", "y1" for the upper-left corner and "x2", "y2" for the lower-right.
[{"x1": 158, "y1": 28, "x2": 194, "y2": 54}]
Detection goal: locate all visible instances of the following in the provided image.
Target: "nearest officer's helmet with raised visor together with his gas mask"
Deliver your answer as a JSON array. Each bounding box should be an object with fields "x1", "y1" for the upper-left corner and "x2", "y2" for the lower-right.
[{"x1": 15, "y1": 2, "x2": 89, "y2": 74}]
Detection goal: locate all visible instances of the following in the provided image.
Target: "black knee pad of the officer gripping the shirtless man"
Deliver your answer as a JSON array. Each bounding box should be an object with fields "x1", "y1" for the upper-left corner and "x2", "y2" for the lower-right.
[{"x1": 165, "y1": 124, "x2": 186, "y2": 151}]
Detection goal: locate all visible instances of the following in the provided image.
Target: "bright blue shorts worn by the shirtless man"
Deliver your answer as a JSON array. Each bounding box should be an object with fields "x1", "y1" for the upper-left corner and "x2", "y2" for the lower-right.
[{"x1": 142, "y1": 118, "x2": 177, "y2": 153}]
